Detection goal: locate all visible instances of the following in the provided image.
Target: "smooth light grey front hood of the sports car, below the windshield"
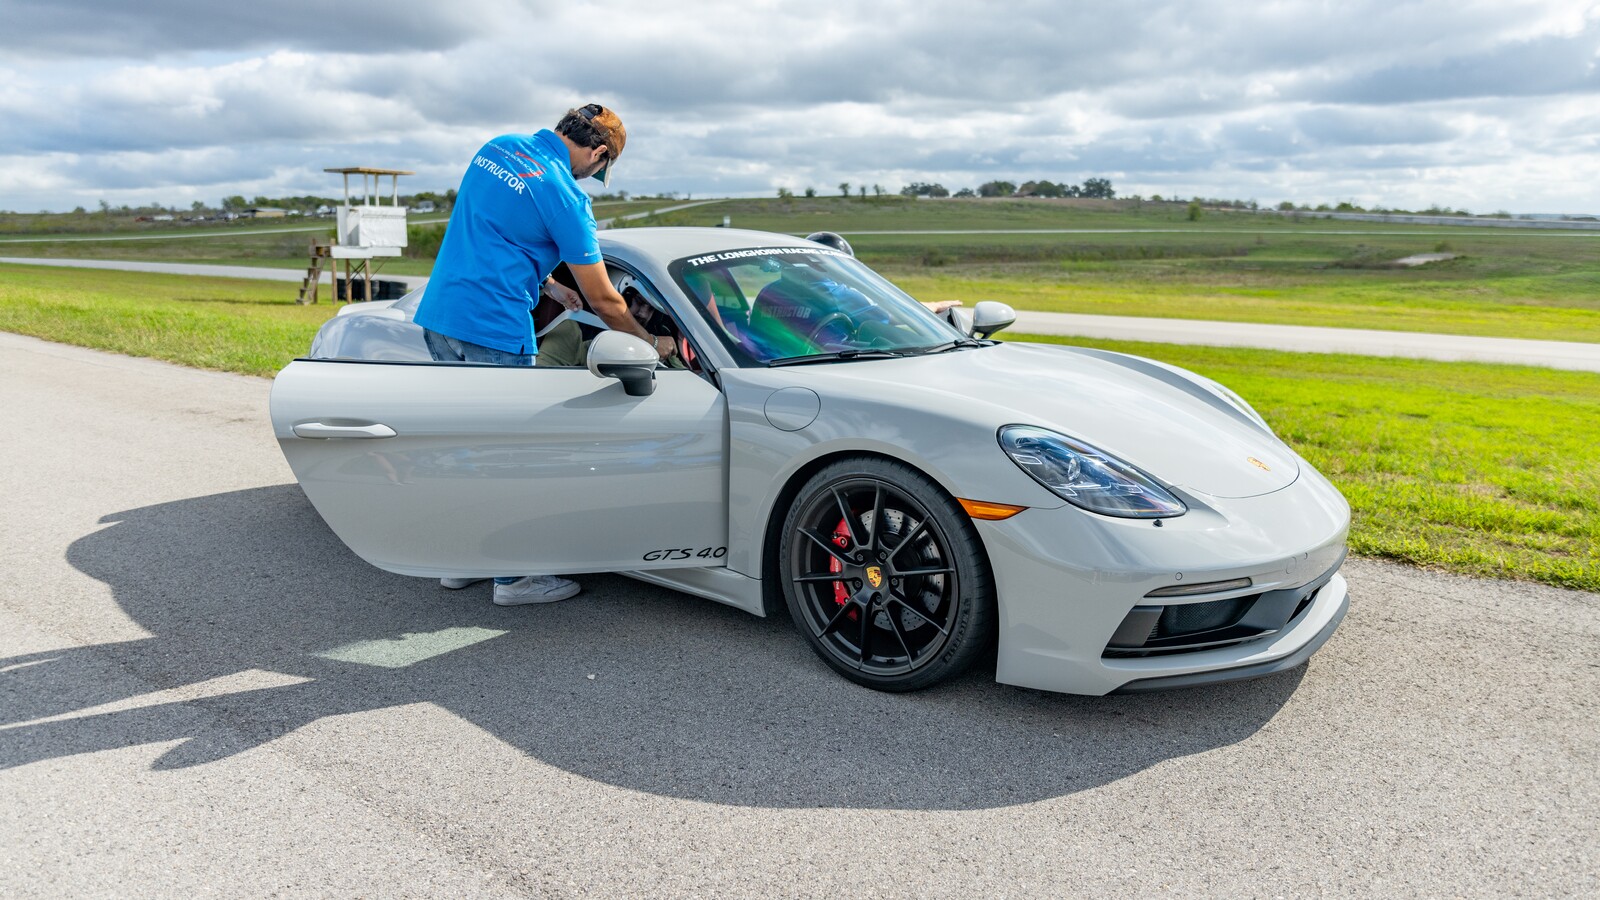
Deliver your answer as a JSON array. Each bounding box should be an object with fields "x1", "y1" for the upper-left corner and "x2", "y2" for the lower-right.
[{"x1": 787, "y1": 343, "x2": 1299, "y2": 498}]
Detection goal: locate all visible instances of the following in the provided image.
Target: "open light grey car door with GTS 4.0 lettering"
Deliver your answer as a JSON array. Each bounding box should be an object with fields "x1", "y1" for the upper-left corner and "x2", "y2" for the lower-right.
[{"x1": 272, "y1": 359, "x2": 728, "y2": 577}]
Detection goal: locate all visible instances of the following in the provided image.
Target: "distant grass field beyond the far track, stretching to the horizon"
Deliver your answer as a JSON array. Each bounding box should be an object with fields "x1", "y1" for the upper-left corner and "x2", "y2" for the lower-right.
[{"x1": 12, "y1": 197, "x2": 1600, "y2": 343}]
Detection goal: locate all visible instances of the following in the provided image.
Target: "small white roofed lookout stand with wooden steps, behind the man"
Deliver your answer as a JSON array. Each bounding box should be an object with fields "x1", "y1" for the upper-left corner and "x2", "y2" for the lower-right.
[{"x1": 298, "y1": 167, "x2": 414, "y2": 303}]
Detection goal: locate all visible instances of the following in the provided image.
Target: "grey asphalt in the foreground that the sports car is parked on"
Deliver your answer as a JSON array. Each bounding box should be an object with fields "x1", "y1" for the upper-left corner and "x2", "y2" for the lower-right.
[{"x1": 0, "y1": 333, "x2": 1600, "y2": 897}]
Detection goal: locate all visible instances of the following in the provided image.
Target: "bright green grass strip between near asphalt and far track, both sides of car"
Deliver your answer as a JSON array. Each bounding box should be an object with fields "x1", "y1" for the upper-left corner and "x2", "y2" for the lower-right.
[{"x1": 0, "y1": 259, "x2": 1600, "y2": 591}]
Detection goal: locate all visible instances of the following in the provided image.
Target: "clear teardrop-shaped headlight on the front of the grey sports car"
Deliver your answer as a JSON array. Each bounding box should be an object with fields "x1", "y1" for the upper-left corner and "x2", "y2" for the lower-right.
[{"x1": 1000, "y1": 424, "x2": 1189, "y2": 519}]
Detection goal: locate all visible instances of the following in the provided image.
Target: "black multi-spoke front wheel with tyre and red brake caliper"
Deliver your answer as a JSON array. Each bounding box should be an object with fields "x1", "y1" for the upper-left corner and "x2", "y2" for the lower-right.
[{"x1": 779, "y1": 458, "x2": 995, "y2": 690}]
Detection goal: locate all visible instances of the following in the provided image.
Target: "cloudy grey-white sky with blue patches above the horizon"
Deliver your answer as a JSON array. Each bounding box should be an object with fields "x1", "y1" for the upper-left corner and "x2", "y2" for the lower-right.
[{"x1": 0, "y1": 0, "x2": 1600, "y2": 213}]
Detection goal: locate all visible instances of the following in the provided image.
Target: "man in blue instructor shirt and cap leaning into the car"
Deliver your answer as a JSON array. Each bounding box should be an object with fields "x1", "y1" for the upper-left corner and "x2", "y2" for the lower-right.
[{"x1": 414, "y1": 102, "x2": 675, "y2": 605}]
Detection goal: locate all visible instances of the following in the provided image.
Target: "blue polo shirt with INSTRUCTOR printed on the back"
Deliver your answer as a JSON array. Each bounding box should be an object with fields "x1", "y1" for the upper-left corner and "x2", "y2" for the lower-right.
[{"x1": 414, "y1": 130, "x2": 600, "y2": 354}]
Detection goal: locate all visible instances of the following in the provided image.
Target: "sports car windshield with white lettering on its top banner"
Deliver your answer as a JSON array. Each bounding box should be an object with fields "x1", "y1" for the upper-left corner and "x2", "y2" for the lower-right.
[{"x1": 670, "y1": 247, "x2": 965, "y2": 365}]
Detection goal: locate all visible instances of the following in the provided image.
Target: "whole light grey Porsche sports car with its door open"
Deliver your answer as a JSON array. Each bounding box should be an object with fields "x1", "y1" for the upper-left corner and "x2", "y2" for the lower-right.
[{"x1": 272, "y1": 229, "x2": 1349, "y2": 695}]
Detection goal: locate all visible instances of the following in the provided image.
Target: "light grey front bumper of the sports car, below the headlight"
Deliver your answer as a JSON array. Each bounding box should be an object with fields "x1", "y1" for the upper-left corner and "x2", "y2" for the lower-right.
[{"x1": 979, "y1": 466, "x2": 1349, "y2": 695}]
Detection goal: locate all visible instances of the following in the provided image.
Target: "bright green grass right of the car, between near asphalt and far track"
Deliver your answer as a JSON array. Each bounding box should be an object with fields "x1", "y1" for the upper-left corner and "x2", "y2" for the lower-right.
[{"x1": 1011, "y1": 335, "x2": 1600, "y2": 591}]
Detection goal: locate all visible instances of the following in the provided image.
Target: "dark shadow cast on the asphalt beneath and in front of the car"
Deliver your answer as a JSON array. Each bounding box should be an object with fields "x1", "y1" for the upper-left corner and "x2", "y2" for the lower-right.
[{"x1": 0, "y1": 485, "x2": 1304, "y2": 809}]
